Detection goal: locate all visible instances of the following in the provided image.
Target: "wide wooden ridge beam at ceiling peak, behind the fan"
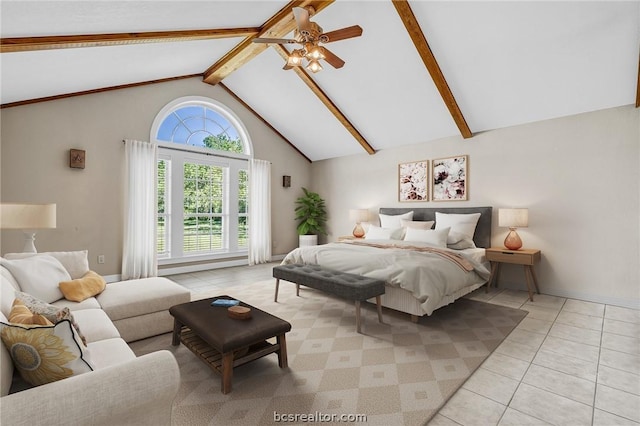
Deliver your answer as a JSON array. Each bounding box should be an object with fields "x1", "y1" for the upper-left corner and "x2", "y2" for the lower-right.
[{"x1": 203, "y1": 0, "x2": 335, "y2": 85}]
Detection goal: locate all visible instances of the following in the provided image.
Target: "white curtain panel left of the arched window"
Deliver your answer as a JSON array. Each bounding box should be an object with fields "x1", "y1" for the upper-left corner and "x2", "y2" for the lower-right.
[{"x1": 122, "y1": 139, "x2": 158, "y2": 280}]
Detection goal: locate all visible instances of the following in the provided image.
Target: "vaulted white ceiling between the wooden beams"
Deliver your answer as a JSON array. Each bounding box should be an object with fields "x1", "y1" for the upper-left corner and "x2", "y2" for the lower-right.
[{"x1": 0, "y1": 0, "x2": 640, "y2": 161}]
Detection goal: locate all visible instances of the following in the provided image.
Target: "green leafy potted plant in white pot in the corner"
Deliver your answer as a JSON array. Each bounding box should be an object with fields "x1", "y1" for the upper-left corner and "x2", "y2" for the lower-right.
[{"x1": 296, "y1": 188, "x2": 327, "y2": 247}]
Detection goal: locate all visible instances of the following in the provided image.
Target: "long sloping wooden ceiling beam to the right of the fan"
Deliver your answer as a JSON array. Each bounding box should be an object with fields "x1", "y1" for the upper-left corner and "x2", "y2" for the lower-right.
[{"x1": 392, "y1": 0, "x2": 473, "y2": 139}]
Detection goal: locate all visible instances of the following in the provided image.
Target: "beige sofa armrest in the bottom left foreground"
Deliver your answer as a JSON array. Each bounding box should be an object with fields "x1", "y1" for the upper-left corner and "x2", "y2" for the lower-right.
[{"x1": 0, "y1": 350, "x2": 180, "y2": 425}]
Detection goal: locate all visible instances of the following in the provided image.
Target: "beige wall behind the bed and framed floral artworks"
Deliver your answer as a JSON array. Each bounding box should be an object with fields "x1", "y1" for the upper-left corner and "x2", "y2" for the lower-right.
[{"x1": 312, "y1": 106, "x2": 640, "y2": 308}]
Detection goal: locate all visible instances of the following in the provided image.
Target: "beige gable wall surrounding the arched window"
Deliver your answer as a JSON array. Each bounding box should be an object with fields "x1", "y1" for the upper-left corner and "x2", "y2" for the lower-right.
[{"x1": 0, "y1": 78, "x2": 311, "y2": 275}]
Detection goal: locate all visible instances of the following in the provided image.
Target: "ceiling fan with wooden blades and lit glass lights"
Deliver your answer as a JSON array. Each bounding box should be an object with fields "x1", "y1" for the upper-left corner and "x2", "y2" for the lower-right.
[{"x1": 253, "y1": 6, "x2": 362, "y2": 73}]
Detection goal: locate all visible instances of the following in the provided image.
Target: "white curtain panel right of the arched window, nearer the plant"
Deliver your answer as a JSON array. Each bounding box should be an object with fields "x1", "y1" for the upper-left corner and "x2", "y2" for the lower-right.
[{"x1": 249, "y1": 159, "x2": 271, "y2": 265}]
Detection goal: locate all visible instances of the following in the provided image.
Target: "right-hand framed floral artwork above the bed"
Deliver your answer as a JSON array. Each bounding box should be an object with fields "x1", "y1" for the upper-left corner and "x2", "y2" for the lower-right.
[{"x1": 431, "y1": 155, "x2": 469, "y2": 201}]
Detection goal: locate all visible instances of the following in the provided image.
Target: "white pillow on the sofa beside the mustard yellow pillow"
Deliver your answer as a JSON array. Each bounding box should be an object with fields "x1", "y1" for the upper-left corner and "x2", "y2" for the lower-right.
[{"x1": 0, "y1": 255, "x2": 71, "y2": 303}]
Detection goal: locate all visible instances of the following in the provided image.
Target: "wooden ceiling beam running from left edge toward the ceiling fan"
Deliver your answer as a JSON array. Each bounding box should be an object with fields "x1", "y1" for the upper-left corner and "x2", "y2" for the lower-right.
[{"x1": 0, "y1": 28, "x2": 260, "y2": 53}]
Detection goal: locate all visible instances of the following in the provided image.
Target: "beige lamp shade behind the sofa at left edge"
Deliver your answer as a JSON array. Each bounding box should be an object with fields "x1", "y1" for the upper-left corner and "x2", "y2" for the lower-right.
[{"x1": 0, "y1": 203, "x2": 56, "y2": 229}]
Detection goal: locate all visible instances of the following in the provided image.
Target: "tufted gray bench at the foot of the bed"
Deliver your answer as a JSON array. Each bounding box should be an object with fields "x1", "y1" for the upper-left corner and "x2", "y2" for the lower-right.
[{"x1": 273, "y1": 264, "x2": 384, "y2": 333}]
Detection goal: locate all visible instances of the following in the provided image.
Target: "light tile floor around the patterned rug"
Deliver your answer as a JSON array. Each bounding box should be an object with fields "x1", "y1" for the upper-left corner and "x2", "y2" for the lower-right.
[{"x1": 170, "y1": 263, "x2": 640, "y2": 426}]
